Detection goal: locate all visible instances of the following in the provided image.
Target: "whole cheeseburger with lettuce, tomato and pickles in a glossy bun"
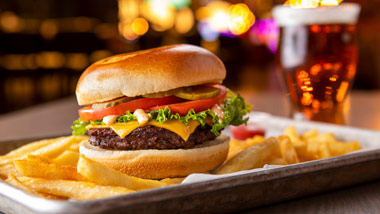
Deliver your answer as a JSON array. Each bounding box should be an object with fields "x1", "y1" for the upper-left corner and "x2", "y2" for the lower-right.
[{"x1": 72, "y1": 45, "x2": 249, "y2": 179}]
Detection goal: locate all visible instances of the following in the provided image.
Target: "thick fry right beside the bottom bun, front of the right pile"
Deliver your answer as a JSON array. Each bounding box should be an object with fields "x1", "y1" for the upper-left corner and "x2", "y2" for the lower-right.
[{"x1": 216, "y1": 137, "x2": 280, "y2": 174}]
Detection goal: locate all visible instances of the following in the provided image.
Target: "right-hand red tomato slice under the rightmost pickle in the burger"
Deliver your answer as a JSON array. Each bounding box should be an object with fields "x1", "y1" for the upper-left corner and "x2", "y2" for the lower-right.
[{"x1": 149, "y1": 85, "x2": 227, "y2": 115}]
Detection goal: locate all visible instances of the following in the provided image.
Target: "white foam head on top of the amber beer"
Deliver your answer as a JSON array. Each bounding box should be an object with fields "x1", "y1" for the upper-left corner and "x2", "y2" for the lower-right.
[{"x1": 273, "y1": 3, "x2": 360, "y2": 26}]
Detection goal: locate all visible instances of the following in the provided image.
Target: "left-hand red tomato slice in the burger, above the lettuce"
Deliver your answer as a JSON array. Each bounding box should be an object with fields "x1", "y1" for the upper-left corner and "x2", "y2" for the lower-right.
[{"x1": 78, "y1": 96, "x2": 182, "y2": 121}]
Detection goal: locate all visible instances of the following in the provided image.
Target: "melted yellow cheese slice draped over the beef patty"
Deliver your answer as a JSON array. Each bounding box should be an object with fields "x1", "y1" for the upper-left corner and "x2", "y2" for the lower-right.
[{"x1": 86, "y1": 120, "x2": 200, "y2": 141}]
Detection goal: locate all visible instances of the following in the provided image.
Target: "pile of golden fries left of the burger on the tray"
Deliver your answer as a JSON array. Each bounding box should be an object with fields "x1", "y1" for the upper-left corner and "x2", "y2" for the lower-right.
[{"x1": 0, "y1": 136, "x2": 183, "y2": 200}]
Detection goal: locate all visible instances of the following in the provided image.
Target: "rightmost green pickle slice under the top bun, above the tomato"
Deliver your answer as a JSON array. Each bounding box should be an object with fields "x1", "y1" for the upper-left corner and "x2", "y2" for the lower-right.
[{"x1": 175, "y1": 85, "x2": 219, "y2": 100}]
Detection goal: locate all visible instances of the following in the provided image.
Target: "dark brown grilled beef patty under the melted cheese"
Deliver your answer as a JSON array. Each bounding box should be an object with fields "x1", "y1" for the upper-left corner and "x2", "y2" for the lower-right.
[{"x1": 88, "y1": 125, "x2": 216, "y2": 150}]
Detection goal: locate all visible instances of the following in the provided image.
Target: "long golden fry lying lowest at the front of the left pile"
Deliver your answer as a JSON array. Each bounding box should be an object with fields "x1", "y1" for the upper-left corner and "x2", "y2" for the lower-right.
[{"x1": 18, "y1": 177, "x2": 134, "y2": 200}]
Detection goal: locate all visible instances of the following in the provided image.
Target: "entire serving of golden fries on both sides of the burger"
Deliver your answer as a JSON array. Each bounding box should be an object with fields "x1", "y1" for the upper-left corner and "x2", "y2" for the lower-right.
[{"x1": 0, "y1": 127, "x2": 361, "y2": 200}]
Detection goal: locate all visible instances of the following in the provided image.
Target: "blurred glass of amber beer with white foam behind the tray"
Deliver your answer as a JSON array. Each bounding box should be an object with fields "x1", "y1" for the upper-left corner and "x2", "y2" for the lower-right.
[{"x1": 273, "y1": 3, "x2": 360, "y2": 124}]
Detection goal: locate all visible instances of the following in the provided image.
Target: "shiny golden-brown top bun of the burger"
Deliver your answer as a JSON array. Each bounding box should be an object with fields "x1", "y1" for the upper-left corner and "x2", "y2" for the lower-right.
[{"x1": 76, "y1": 45, "x2": 226, "y2": 105}]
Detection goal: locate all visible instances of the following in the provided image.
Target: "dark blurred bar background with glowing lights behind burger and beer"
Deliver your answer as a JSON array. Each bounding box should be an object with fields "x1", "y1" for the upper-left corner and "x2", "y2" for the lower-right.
[{"x1": 0, "y1": 0, "x2": 380, "y2": 114}]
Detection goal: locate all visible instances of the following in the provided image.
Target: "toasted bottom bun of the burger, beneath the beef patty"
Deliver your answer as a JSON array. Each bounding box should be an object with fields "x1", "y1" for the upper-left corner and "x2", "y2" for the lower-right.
[{"x1": 79, "y1": 135, "x2": 230, "y2": 179}]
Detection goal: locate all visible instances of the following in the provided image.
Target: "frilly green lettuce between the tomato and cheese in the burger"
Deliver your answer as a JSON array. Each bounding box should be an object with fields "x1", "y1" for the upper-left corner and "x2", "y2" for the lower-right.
[{"x1": 71, "y1": 90, "x2": 252, "y2": 136}]
